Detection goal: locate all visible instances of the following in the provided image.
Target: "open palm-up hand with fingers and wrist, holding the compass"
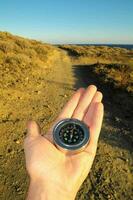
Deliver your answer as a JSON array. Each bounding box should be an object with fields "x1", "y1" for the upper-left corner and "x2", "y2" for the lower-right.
[{"x1": 24, "y1": 85, "x2": 103, "y2": 200}]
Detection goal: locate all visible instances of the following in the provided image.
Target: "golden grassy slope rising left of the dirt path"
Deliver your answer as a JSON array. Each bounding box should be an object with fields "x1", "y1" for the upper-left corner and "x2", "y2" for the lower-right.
[{"x1": 0, "y1": 32, "x2": 70, "y2": 88}]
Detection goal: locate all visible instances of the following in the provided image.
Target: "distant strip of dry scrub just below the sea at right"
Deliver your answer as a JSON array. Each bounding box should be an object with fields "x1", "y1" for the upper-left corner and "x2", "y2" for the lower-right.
[{"x1": 59, "y1": 45, "x2": 133, "y2": 63}]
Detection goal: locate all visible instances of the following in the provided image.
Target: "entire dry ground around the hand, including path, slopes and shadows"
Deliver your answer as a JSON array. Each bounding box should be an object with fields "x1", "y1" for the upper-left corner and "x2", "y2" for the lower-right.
[{"x1": 0, "y1": 32, "x2": 133, "y2": 200}]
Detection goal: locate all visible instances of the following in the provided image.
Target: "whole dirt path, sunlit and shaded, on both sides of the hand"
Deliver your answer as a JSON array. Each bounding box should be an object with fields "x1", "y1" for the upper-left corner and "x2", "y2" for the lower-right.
[{"x1": 0, "y1": 63, "x2": 133, "y2": 200}]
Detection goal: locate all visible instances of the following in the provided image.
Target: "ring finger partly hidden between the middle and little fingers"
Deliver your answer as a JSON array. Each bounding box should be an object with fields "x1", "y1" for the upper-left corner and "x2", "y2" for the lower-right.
[{"x1": 83, "y1": 91, "x2": 103, "y2": 126}]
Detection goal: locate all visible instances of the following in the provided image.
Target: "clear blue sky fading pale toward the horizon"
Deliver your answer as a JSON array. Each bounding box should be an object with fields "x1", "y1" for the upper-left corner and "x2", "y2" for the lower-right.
[{"x1": 0, "y1": 0, "x2": 133, "y2": 44}]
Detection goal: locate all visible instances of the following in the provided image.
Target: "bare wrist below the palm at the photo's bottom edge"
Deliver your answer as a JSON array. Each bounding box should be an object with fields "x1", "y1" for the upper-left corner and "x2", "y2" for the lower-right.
[{"x1": 26, "y1": 179, "x2": 76, "y2": 200}]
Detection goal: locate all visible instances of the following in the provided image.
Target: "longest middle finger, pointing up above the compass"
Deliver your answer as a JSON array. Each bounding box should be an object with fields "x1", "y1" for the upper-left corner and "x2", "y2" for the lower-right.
[{"x1": 72, "y1": 85, "x2": 97, "y2": 120}]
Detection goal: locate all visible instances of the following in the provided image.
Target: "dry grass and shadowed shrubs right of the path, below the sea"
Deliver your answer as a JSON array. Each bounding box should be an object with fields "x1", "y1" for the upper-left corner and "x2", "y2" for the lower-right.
[{"x1": 59, "y1": 45, "x2": 133, "y2": 93}]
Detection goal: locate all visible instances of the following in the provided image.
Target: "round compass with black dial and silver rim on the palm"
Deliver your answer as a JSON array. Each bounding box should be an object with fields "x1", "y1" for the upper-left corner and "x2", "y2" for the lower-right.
[{"x1": 53, "y1": 118, "x2": 90, "y2": 153}]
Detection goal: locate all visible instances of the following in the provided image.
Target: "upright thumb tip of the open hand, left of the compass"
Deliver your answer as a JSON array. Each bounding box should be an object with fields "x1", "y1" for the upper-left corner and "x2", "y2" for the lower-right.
[{"x1": 27, "y1": 120, "x2": 40, "y2": 139}]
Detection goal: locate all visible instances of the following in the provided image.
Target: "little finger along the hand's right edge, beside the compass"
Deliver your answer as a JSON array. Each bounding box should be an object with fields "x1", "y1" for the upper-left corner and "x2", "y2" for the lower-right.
[{"x1": 85, "y1": 103, "x2": 104, "y2": 156}]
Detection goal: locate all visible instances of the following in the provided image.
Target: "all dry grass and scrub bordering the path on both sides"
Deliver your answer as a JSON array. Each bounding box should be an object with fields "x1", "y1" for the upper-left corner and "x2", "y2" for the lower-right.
[{"x1": 0, "y1": 32, "x2": 133, "y2": 92}]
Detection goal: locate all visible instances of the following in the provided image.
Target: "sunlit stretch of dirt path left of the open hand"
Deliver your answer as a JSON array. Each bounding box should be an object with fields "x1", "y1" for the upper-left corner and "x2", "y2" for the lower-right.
[{"x1": 0, "y1": 63, "x2": 74, "y2": 200}]
